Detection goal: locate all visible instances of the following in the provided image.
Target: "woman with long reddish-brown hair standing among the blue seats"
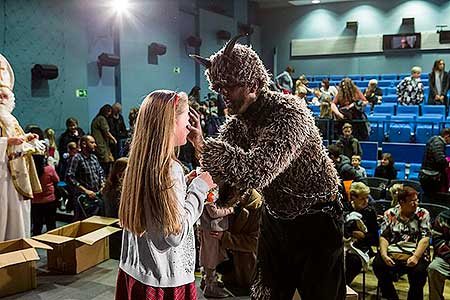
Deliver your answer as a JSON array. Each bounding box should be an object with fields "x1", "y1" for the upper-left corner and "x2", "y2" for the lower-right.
[{"x1": 331, "y1": 78, "x2": 369, "y2": 141}]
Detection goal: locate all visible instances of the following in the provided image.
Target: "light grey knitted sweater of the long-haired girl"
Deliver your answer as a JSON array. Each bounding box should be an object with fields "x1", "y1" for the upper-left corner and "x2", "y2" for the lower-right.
[{"x1": 119, "y1": 162, "x2": 208, "y2": 287}]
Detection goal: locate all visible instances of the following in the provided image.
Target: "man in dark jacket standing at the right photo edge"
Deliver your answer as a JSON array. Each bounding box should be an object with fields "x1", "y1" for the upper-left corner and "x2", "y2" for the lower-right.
[{"x1": 419, "y1": 128, "x2": 450, "y2": 194}]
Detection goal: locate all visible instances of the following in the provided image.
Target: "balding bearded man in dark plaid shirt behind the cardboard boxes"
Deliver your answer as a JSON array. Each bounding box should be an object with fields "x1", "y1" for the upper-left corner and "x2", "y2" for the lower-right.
[{"x1": 66, "y1": 135, "x2": 105, "y2": 220}]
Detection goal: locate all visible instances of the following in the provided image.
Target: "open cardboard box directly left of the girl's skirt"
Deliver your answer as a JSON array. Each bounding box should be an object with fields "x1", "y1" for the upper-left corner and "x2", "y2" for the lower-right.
[{"x1": 33, "y1": 216, "x2": 120, "y2": 274}]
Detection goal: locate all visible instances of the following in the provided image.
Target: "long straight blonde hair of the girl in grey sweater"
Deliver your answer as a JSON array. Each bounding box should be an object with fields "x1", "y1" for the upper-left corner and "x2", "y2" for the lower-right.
[{"x1": 119, "y1": 90, "x2": 188, "y2": 236}]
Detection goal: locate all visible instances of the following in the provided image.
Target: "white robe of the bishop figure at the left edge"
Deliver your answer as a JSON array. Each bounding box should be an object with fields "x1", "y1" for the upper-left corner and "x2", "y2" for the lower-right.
[{"x1": 0, "y1": 137, "x2": 31, "y2": 242}]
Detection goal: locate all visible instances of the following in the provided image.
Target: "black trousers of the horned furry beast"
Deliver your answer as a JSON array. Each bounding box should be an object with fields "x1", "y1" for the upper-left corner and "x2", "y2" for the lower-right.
[{"x1": 252, "y1": 204, "x2": 346, "y2": 300}]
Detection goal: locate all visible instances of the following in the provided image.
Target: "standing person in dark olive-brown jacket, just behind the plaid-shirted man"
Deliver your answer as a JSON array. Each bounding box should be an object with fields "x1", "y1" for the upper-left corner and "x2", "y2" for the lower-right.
[{"x1": 91, "y1": 104, "x2": 117, "y2": 175}]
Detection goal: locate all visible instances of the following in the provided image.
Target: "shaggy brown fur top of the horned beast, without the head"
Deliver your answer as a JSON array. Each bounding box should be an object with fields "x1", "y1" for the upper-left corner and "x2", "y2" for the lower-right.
[{"x1": 202, "y1": 90, "x2": 339, "y2": 215}]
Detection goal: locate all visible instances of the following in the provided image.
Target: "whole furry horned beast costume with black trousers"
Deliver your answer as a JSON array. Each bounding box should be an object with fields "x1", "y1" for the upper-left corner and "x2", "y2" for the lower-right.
[{"x1": 194, "y1": 36, "x2": 345, "y2": 299}]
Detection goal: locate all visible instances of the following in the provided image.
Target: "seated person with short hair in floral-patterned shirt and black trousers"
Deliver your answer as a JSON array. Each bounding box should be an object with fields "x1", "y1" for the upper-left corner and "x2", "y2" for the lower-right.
[{"x1": 373, "y1": 186, "x2": 431, "y2": 300}]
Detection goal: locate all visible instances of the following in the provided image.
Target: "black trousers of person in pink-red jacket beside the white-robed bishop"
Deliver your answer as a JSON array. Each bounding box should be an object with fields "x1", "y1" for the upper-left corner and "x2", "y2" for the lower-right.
[{"x1": 31, "y1": 201, "x2": 58, "y2": 235}]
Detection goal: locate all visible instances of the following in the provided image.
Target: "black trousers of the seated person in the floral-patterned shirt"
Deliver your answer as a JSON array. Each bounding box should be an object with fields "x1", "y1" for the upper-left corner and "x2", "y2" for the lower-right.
[{"x1": 372, "y1": 254, "x2": 430, "y2": 300}]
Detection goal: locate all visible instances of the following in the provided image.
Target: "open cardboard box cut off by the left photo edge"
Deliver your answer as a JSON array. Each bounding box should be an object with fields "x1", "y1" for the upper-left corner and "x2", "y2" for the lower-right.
[{"x1": 0, "y1": 239, "x2": 52, "y2": 298}]
